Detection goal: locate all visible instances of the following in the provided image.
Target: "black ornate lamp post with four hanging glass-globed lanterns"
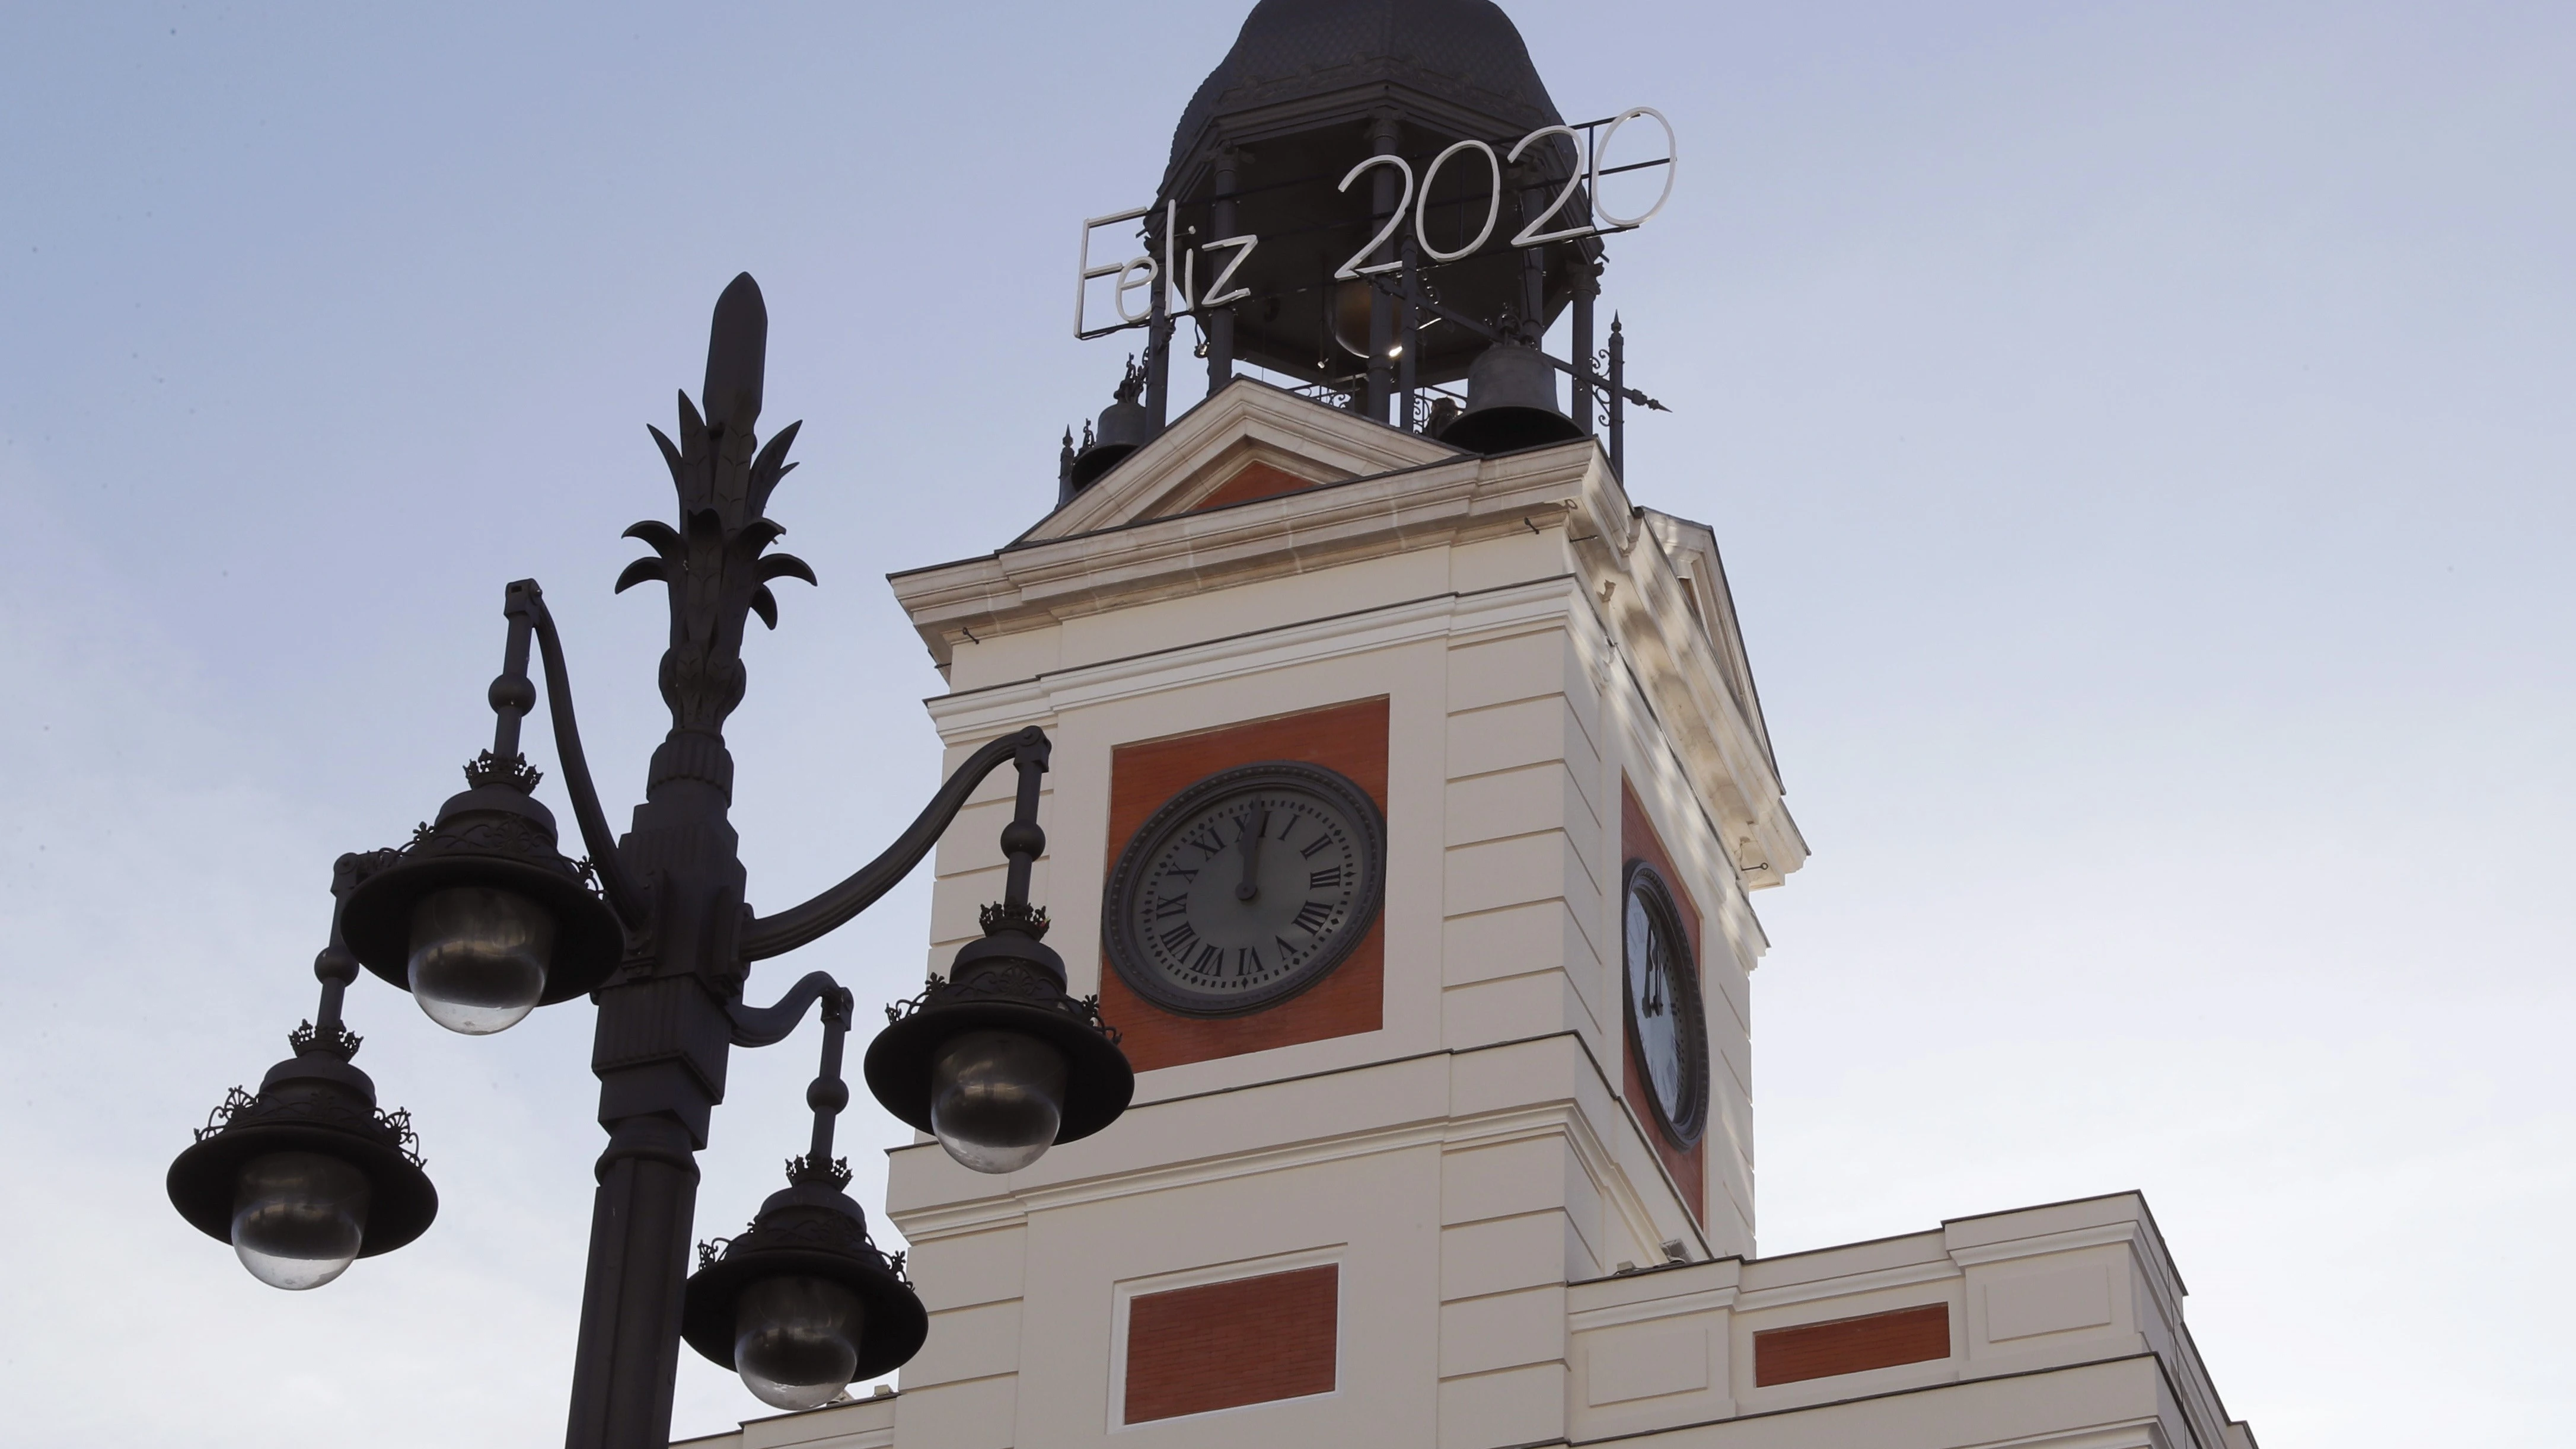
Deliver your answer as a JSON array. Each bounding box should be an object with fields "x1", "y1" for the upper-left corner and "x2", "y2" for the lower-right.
[{"x1": 170, "y1": 273, "x2": 1136, "y2": 1449}]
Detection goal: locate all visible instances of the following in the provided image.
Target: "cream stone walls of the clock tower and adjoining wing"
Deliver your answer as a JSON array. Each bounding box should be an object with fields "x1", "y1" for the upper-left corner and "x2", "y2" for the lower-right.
[{"x1": 693, "y1": 381, "x2": 2252, "y2": 1449}]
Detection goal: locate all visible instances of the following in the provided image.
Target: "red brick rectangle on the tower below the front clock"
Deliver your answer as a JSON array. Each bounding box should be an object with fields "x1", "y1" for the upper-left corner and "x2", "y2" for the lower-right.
[{"x1": 1126, "y1": 1263, "x2": 1342, "y2": 1424}]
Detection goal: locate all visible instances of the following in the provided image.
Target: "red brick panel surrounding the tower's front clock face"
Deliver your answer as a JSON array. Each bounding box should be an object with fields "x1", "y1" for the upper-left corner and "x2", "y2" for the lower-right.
[{"x1": 1100, "y1": 695, "x2": 1386, "y2": 1071}]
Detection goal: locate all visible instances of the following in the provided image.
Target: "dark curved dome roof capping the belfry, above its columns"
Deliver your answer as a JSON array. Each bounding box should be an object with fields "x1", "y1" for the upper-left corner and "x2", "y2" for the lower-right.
[{"x1": 1172, "y1": 0, "x2": 1561, "y2": 170}]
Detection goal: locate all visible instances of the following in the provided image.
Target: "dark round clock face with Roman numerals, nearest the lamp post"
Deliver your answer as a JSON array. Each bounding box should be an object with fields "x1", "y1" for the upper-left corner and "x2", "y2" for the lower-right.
[{"x1": 1102, "y1": 762, "x2": 1386, "y2": 1017}]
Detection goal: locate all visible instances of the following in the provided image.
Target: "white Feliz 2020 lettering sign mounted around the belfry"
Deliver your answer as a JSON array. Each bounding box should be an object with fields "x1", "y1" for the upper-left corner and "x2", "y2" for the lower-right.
[{"x1": 1074, "y1": 106, "x2": 1679, "y2": 337}]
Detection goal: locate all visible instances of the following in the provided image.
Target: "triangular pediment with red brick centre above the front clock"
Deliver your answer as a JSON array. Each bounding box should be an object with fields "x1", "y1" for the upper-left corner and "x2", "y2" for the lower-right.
[{"x1": 1020, "y1": 378, "x2": 1461, "y2": 543}]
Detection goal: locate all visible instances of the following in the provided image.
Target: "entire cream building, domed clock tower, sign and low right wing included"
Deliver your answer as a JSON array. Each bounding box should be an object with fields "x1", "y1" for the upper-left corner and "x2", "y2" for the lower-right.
[{"x1": 680, "y1": 0, "x2": 2252, "y2": 1449}]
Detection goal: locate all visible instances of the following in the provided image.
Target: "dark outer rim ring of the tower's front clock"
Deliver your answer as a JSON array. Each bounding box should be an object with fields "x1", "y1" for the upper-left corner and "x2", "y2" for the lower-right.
[{"x1": 1100, "y1": 759, "x2": 1386, "y2": 1019}]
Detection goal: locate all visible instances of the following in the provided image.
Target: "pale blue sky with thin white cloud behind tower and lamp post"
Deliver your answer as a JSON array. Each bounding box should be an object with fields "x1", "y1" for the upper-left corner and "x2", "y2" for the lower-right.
[{"x1": 0, "y1": 0, "x2": 2576, "y2": 1449}]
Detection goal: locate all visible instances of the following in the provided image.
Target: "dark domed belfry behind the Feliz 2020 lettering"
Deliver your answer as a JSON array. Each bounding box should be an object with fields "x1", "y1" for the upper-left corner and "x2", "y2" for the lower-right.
[{"x1": 1141, "y1": 0, "x2": 1600, "y2": 386}]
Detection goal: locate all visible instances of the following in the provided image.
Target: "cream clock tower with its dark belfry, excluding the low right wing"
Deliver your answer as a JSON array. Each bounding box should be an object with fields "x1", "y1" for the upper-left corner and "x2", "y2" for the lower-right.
[{"x1": 865, "y1": 0, "x2": 1806, "y2": 1449}]
